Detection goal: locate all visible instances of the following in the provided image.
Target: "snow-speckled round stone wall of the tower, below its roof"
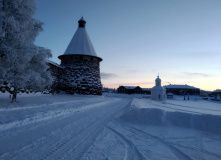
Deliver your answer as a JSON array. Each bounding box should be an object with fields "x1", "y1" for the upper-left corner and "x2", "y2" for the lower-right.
[{"x1": 59, "y1": 59, "x2": 102, "y2": 95}]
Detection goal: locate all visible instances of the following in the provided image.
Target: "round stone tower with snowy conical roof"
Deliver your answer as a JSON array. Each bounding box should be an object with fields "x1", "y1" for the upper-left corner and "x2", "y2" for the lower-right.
[{"x1": 58, "y1": 17, "x2": 102, "y2": 95}]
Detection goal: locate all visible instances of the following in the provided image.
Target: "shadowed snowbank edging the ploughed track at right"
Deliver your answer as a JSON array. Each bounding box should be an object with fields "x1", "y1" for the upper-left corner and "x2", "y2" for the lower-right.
[{"x1": 121, "y1": 99, "x2": 221, "y2": 134}]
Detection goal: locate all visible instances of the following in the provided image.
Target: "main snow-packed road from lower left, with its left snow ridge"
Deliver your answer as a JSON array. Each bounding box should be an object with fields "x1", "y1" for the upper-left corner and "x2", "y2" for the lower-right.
[{"x1": 0, "y1": 98, "x2": 130, "y2": 160}]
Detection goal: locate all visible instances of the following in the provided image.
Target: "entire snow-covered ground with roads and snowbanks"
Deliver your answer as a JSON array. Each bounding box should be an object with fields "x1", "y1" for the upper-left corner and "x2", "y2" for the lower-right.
[{"x1": 0, "y1": 94, "x2": 221, "y2": 160}]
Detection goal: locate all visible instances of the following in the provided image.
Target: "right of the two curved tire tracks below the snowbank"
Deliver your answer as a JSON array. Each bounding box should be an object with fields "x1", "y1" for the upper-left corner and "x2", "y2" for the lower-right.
[{"x1": 124, "y1": 126, "x2": 193, "y2": 160}]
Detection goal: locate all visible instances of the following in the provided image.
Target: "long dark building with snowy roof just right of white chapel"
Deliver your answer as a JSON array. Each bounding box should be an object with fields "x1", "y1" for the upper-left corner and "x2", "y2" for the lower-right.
[{"x1": 164, "y1": 84, "x2": 200, "y2": 95}]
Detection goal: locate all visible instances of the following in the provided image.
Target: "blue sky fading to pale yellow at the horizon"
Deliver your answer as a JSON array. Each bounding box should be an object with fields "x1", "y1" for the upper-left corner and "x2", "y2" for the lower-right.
[{"x1": 35, "y1": 0, "x2": 221, "y2": 90}]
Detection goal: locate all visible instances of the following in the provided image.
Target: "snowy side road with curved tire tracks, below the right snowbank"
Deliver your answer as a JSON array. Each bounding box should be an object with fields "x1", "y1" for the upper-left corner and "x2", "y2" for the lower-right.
[{"x1": 82, "y1": 121, "x2": 221, "y2": 160}]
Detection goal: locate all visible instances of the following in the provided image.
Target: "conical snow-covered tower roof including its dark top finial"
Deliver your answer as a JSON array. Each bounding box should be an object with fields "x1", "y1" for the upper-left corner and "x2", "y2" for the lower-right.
[{"x1": 64, "y1": 17, "x2": 97, "y2": 56}]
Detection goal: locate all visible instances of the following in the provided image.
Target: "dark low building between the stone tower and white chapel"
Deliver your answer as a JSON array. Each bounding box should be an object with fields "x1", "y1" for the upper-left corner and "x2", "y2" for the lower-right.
[{"x1": 117, "y1": 86, "x2": 142, "y2": 94}]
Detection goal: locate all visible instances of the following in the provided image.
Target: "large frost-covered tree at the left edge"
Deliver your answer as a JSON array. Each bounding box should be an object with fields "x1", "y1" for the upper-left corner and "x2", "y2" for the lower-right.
[{"x1": 0, "y1": 0, "x2": 51, "y2": 101}]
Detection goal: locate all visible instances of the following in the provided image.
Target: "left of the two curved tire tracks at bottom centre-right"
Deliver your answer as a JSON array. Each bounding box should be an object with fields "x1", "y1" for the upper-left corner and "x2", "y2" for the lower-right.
[{"x1": 107, "y1": 126, "x2": 145, "y2": 160}]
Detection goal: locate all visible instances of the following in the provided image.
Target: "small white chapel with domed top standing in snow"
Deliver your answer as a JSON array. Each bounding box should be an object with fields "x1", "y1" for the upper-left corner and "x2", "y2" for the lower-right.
[{"x1": 151, "y1": 76, "x2": 166, "y2": 101}]
